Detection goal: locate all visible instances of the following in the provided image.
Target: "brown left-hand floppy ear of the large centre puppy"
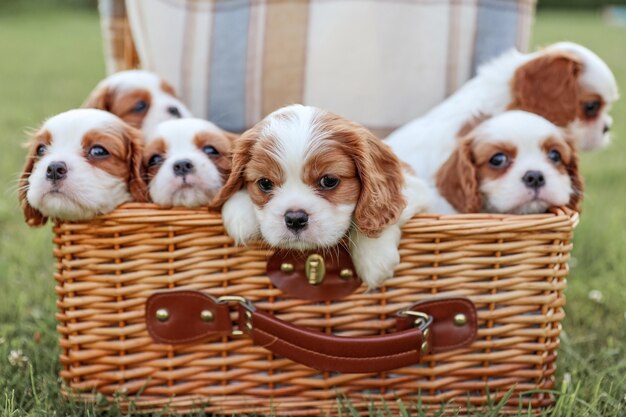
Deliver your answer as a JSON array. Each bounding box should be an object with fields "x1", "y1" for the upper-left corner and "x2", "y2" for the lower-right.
[{"x1": 209, "y1": 127, "x2": 259, "y2": 207}]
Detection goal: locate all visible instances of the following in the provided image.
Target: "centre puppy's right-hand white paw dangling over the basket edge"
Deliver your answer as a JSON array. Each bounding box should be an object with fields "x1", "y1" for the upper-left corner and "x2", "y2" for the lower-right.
[{"x1": 350, "y1": 225, "x2": 401, "y2": 289}]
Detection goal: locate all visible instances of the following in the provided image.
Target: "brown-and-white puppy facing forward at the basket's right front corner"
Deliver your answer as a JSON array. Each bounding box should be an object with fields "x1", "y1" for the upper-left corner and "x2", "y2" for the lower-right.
[{"x1": 433, "y1": 110, "x2": 583, "y2": 214}]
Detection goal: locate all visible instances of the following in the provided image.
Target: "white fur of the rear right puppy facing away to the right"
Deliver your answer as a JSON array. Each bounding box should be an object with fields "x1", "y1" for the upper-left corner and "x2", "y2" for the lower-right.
[{"x1": 386, "y1": 42, "x2": 618, "y2": 193}]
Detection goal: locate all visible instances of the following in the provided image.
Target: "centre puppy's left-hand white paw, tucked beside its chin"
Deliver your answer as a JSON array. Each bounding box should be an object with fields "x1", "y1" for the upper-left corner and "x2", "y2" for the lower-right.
[{"x1": 222, "y1": 190, "x2": 259, "y2": 245}]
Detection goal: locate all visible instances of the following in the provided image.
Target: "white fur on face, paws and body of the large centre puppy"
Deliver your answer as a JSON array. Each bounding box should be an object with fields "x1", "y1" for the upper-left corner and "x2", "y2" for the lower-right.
[{"x1": 222, "y1": 105, "x2": 429, "y2": 288}]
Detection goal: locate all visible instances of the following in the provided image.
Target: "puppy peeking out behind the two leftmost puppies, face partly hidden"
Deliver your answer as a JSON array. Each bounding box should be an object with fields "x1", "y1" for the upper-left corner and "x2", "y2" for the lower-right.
[{"x1": 82, "y1": 70, "x2": 192, "y2": 135}]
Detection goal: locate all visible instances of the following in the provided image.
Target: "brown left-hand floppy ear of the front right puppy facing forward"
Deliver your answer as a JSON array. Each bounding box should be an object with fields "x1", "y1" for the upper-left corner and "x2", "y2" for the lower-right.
[{"x1": 437, "y1": 136, "x2": 482, "y2": 213}]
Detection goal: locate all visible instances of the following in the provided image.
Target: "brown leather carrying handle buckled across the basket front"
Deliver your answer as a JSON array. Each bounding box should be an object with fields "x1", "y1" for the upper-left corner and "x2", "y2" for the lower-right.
[{"x1": 146, "y1": 291, "x2": 476, "y2": 373}]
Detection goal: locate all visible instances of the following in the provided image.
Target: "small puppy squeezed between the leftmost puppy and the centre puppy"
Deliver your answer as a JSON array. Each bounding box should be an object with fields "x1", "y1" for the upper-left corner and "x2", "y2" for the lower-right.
[{"x1": 143, "y1": 118, "x2": 237, "y2": 207}]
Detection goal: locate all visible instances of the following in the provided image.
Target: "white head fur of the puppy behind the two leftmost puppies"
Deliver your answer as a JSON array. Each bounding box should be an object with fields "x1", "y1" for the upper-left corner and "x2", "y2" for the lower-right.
[{"x1": 88, "y1": 70, "x2": 192, "y2": 136}]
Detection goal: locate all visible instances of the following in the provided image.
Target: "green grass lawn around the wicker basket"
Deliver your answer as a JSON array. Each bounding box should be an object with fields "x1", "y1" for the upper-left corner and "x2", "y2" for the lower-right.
[{"x1": 0, "y1": 9, "x2": 626, "y2": 417}]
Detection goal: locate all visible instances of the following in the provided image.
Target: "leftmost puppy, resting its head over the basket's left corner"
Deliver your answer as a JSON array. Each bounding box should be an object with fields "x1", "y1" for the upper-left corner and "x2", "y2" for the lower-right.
[{"x1": 19, "y1": 109, "x2": 147, "y2": 226}]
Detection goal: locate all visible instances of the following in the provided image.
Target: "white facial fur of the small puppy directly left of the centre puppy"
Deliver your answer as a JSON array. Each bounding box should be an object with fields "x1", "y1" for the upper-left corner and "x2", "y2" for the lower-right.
[{"x1": 148, "y1": 118, "x2": 224, "y2": 207}]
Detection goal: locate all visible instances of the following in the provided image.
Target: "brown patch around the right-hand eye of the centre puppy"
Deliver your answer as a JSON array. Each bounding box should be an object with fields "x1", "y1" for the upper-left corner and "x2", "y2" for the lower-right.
[{"x1": 303, "y1": 138, "x2": 361, "y2": 204}]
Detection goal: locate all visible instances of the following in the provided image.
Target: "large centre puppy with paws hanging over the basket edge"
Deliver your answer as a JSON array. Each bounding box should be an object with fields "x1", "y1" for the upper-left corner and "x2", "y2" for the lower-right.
[{"x1": 213, "y1": 105, "x2": 430, "y2": 288}]
